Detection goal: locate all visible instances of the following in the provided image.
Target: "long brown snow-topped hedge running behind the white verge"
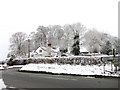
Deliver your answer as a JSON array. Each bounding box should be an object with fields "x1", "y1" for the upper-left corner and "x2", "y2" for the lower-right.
[{"x1": 20, "y1": 56, "x2": 102, "y2": 65}]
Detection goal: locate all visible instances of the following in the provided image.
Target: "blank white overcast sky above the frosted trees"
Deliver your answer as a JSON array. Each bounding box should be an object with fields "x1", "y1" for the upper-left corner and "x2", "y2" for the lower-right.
[{"x1": 0, "y1": 0, "x2": 119, "y2": 60}]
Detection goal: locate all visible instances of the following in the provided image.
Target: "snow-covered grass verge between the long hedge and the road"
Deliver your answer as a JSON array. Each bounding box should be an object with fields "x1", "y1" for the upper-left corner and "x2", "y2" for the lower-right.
[{"x1": 19, "y1": 63, "x2": 120, "y2": 77}]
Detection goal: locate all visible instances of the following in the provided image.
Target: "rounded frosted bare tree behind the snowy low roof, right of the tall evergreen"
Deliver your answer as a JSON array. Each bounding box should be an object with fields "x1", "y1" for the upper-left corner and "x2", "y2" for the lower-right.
[{"x1": 84, "y1": 29, "x2": 104, "y2": 53}]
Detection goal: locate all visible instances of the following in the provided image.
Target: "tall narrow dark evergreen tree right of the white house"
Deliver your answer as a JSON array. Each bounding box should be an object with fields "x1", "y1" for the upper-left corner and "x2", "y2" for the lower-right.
[{"x1": 72, "y1": 34, "x2": 80, "y2": 55}]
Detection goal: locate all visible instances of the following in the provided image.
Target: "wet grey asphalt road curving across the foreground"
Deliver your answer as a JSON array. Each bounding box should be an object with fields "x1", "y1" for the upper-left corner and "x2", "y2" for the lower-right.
[{"x1": 2, "y1": 68, "x2": 118, "y2": 88}]
